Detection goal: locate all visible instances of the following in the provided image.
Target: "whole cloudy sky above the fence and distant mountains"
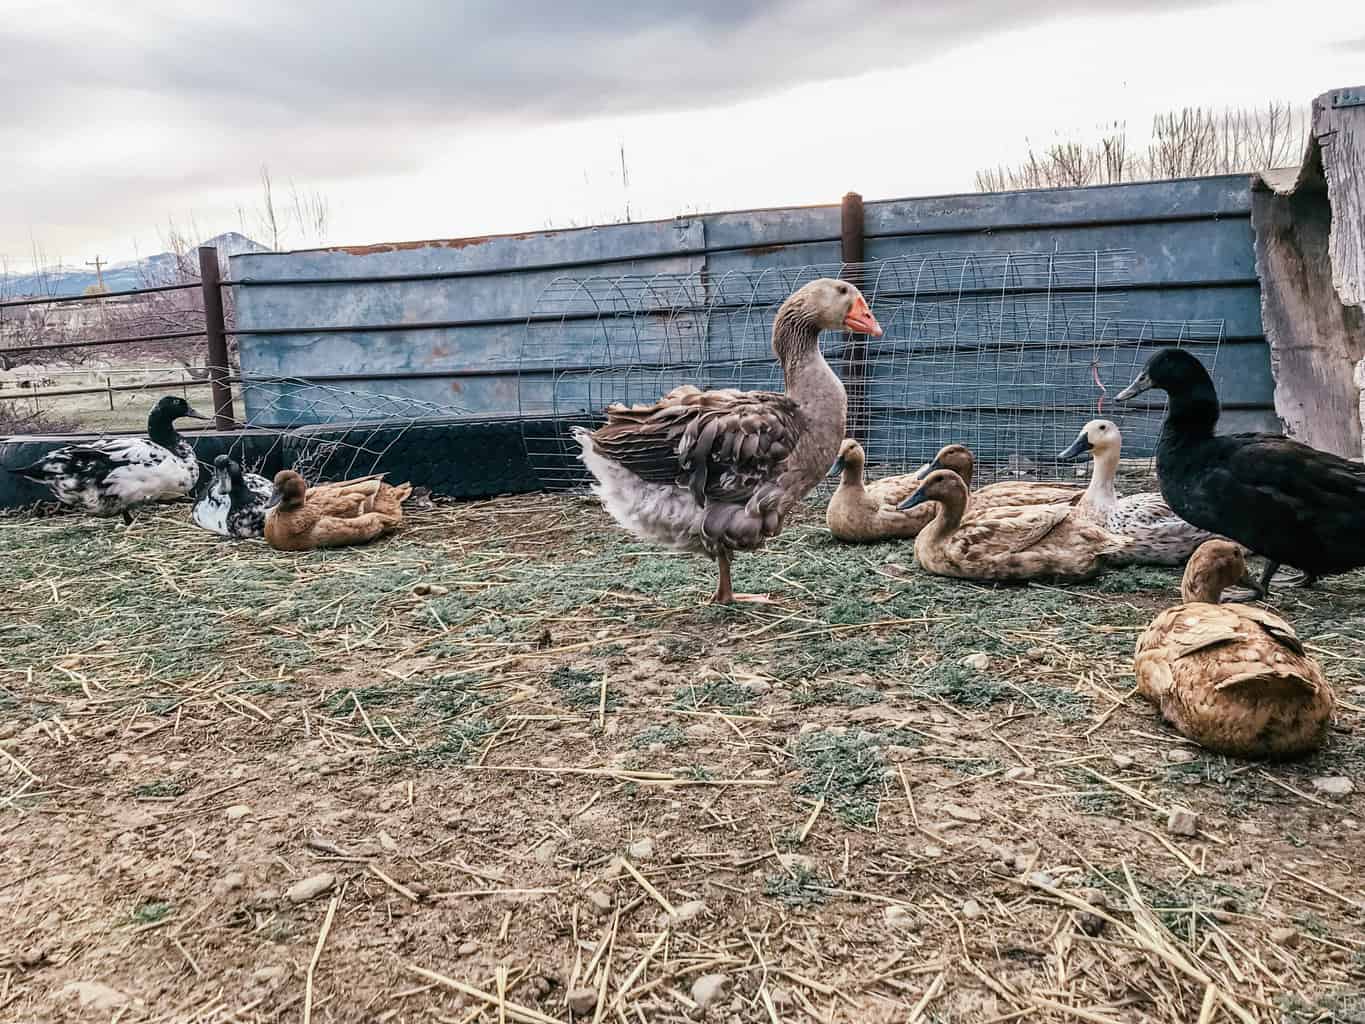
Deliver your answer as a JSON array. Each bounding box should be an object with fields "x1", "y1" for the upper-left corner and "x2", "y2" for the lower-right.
[{"x1": 0, "y1": 0, "x2": 1365, "y2": 269}]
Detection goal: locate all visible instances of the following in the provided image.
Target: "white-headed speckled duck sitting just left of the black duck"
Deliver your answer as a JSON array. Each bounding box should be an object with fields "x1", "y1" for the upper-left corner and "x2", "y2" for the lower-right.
[{"x1": 1057, "y1": 419, "x2": 1213, "y2": 565}]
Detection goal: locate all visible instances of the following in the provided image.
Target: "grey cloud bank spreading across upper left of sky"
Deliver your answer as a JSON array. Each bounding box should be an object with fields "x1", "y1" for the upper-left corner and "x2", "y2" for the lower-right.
[{"x1": 0, "y1": 0, "x2": 1217, "y2": 251}]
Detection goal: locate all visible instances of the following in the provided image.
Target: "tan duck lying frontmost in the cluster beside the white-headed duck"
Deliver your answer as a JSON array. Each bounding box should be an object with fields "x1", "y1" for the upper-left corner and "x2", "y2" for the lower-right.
[{"x1": 901, "y1": 470, "x2": 1132, "y2": 583}]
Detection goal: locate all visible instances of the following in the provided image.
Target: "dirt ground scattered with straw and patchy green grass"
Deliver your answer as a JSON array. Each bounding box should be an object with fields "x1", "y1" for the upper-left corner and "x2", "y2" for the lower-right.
[{"x1": 0, "y1": 496, "x2": 1365, "y2": 1024}]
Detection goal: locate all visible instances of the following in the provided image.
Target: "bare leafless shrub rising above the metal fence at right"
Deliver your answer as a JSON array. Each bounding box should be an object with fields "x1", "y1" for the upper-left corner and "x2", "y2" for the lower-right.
[{"x1": 976, "y1": 102, "x2": 1309, "y2": 193}]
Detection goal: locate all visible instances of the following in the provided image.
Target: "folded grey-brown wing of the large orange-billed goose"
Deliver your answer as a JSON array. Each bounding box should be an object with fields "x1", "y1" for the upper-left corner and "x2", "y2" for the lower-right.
[{"x1": 592, "y1": 385, "x2": 804, "y2": 505}]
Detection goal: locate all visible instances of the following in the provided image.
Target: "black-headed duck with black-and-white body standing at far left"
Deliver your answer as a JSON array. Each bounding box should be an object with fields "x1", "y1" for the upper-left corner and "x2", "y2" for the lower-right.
[{"x1": 10, "y1": 395, "x2": 207, "y2": 526}]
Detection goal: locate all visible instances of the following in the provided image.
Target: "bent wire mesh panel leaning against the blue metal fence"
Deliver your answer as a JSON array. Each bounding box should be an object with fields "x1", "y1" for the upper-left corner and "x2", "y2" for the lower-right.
[{"x1": 517, "y1": 250, "x2": 1223, "y2": 489}]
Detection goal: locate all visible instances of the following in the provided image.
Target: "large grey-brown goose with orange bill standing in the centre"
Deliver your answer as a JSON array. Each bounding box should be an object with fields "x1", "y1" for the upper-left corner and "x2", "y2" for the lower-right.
[{"x1": 573, "y1": 277, "x2": 882, "y2": 605}]
